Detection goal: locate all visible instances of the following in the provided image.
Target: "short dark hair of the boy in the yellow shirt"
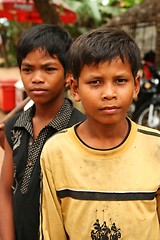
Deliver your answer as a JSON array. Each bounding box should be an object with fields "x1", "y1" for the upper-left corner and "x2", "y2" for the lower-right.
[{"x1": 69, "y1": 27, "x2": 141, "y2": 81}]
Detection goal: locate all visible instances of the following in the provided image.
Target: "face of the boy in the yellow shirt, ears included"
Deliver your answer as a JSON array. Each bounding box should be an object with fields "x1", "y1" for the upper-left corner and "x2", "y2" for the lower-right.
[{"x1": 71, "y1": 58, "x2": 140, "y2": 124}]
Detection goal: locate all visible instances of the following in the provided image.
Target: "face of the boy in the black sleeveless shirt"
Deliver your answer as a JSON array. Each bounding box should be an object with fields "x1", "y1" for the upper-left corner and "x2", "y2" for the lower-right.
[{"x1": 20, "y1": 49, "x2": 65, "y2": 107}]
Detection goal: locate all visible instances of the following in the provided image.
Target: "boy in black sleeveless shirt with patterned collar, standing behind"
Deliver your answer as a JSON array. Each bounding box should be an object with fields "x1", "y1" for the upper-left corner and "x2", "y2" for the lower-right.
[{"x1": 0, "y1": 24, "x2": 84, "y2": 240}]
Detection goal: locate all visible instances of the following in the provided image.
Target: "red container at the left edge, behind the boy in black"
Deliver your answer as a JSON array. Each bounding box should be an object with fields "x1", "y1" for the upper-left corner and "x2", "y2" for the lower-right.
[{"x1": 0, "y1": 80, "x2": 17, "y2": 113}]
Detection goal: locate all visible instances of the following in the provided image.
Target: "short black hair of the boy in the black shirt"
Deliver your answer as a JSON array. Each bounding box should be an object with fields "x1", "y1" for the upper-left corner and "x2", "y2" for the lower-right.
[{"x1": 17, "y1": 24, "x2": 73, "y2": 73}]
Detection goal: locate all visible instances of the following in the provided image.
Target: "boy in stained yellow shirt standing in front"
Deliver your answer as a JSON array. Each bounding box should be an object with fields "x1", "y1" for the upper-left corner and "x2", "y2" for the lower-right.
[{"x1": 41, "y1": 28, "x2": 160, "y2": 240}]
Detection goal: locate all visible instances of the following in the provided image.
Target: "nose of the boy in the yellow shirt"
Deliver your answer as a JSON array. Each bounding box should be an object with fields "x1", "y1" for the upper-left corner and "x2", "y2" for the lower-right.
[{"x1": 101, "y1": 84, "x2": 117, "y2": 100}]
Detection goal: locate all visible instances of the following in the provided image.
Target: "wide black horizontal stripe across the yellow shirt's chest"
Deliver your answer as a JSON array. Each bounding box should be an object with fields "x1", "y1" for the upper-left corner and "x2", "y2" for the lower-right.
[{"x1": 57, "y1": 189, "x2": 156, "y2": 201}]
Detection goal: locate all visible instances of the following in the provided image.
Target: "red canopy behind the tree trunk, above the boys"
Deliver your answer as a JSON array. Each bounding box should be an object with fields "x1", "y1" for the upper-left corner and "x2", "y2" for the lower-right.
[{"x1": 0, "y1": 0, "x2": 77, "y2": 23}]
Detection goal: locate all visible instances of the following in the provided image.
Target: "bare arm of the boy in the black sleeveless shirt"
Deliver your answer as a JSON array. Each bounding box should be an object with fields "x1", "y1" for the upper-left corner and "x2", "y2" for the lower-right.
[{"x1": 0, "y1": 136, "x2": 15, "y2": 240}]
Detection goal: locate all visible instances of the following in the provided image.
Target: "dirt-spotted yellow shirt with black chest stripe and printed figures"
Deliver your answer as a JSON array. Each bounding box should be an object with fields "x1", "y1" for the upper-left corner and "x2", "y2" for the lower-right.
[{"x1": 41, "y1": 122, "x2": 160, "y2": 240}]
